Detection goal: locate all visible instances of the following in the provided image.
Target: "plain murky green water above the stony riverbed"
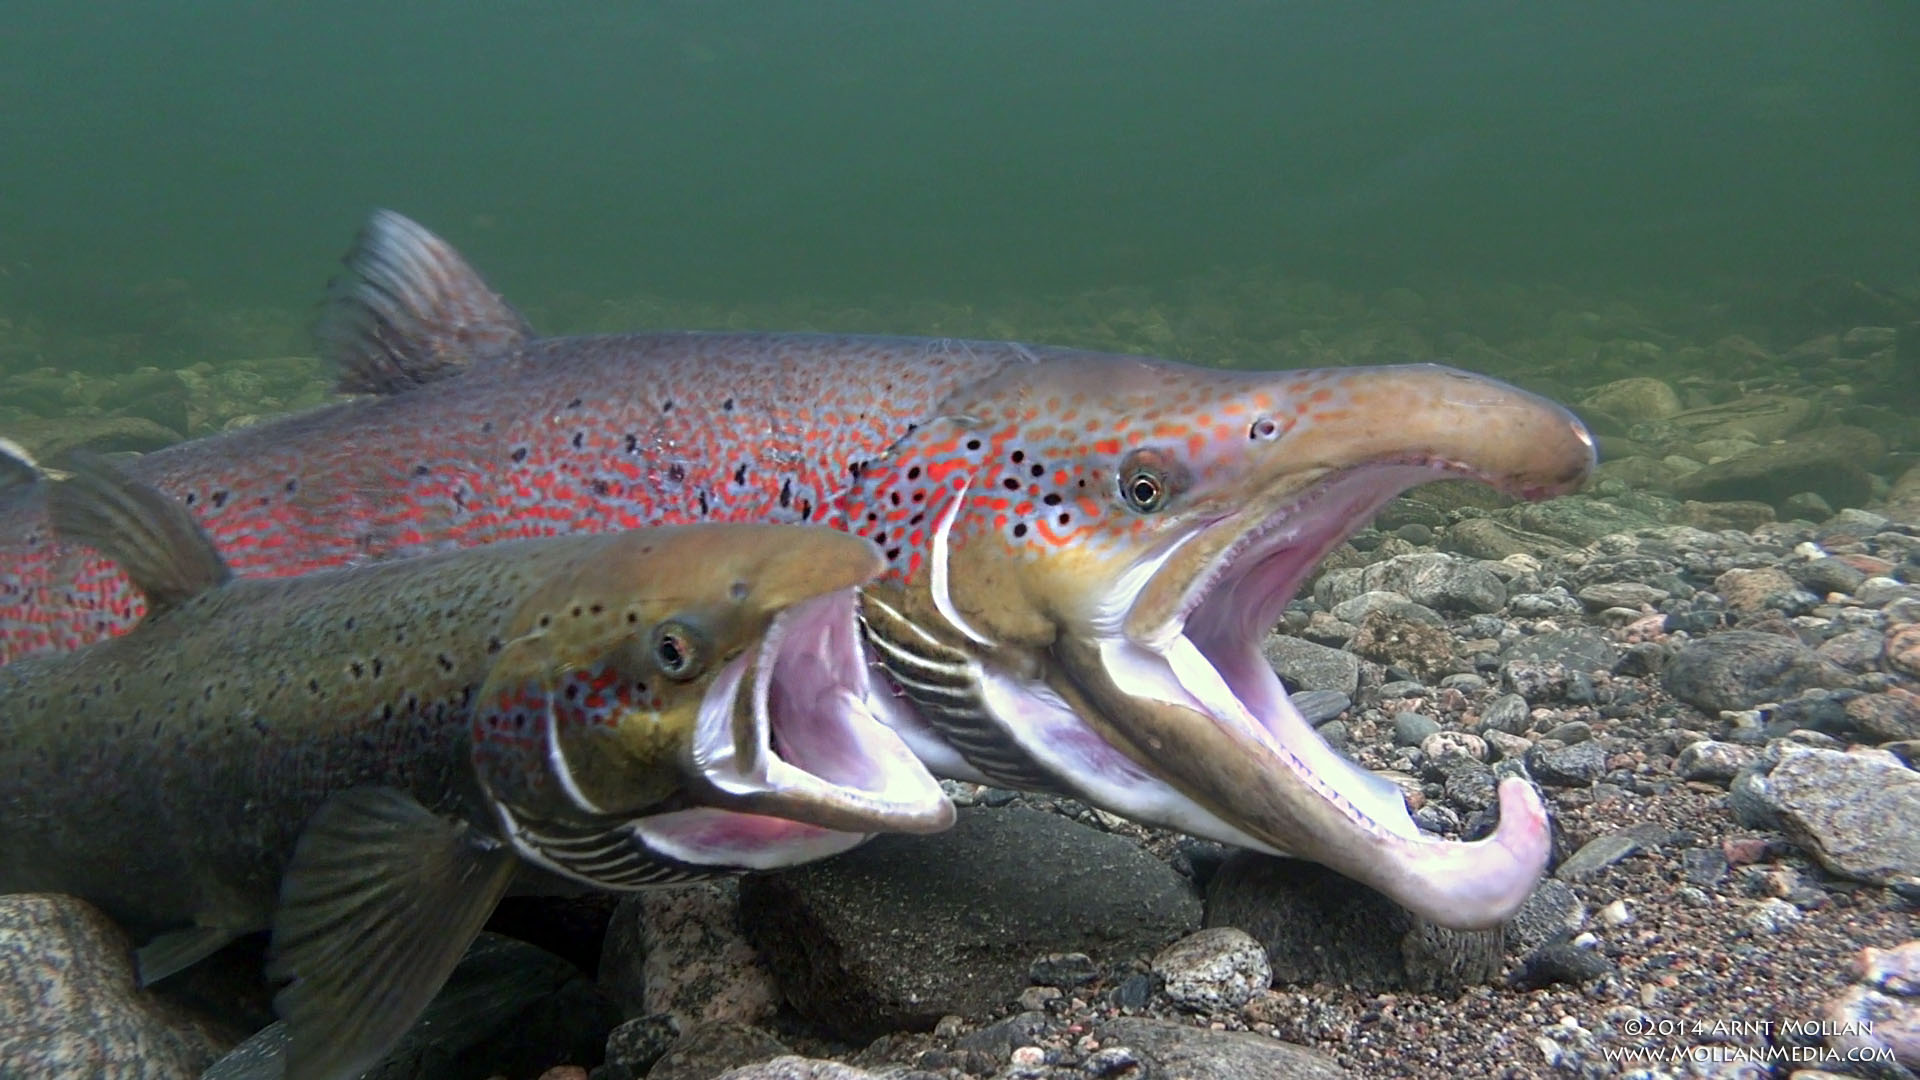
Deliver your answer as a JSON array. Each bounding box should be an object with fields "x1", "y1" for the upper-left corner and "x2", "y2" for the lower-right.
[{"x1": 0, "y1": 0, "x2": 1920, "y2": 329}]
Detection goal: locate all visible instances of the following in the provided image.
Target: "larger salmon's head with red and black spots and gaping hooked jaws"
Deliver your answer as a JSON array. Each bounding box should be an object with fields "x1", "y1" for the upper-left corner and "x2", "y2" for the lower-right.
[{"x1": 862, "y1": 354, "x2": 1594, "y2": 926}]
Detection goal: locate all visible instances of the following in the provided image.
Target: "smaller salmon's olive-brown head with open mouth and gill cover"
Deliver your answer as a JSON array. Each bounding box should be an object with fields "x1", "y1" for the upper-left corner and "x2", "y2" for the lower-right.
[{"x1": 472, "y1": 525, "x2": 952, "y2": 884}]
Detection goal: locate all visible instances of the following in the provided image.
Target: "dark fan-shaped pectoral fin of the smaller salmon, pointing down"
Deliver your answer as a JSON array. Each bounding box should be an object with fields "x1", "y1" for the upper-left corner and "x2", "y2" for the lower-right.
[{"x1": 267, "y1": 788, "x2": 515, "y2": 1080}]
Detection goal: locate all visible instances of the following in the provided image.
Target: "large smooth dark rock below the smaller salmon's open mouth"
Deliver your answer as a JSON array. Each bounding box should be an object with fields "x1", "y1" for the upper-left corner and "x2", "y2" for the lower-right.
[{"x1": 741, "y1": 807, "x2": 1200, "y2": 1040}]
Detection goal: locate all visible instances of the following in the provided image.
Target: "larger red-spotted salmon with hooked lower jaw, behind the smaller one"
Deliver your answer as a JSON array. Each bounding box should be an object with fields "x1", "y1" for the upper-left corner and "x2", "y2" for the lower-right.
[{"x1": 0, "y1": 211, "x2": 1594, "y2": 926}]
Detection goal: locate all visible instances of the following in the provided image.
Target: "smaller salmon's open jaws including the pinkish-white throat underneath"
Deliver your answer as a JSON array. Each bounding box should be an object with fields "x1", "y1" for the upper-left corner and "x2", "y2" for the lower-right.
[{"x1": 636, "y1": 590, "x2": 954, "y2": 871}]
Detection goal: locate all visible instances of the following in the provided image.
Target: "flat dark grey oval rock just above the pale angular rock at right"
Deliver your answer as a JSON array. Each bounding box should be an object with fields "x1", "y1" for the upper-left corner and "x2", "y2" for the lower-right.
[{"x1": 1661, "y1": 630, "x2": 1853, "y2": 717}]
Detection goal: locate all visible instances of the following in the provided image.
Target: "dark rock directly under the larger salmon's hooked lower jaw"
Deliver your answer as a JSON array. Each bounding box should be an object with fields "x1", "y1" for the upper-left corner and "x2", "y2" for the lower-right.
[{"x1": 1206, "y1": 851, "x2": 1503, "y2": 992}]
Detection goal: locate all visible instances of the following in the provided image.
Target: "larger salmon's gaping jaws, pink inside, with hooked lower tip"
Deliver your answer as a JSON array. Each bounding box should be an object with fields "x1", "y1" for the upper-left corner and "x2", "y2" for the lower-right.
[{"x1": 1094, "y1": 459, "x2": 1549, "y2": 928}]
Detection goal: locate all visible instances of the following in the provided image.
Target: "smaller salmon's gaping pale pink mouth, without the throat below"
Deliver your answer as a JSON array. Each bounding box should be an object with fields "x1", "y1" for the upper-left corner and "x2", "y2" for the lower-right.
[{"x1": 689, "y1": 590, "x2": 954, "y2": 845}]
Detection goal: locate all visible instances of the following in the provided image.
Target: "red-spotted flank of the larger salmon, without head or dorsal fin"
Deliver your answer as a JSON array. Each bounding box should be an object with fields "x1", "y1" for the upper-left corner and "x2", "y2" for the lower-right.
[{"x1": 0, "y1": 334, "x2": 1013, "y2": 661}]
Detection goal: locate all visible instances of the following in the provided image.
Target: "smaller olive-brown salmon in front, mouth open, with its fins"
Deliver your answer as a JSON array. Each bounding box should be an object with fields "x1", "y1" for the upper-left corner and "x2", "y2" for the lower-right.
[{"x1": 0, "y1": 451, "x2": 952, "y2": 1080}]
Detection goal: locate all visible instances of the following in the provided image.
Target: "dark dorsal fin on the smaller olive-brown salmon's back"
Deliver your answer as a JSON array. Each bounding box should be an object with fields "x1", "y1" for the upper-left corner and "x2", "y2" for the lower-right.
[{"x1": 46, "y1": 455, "x2": 232, "y2": 613}]
